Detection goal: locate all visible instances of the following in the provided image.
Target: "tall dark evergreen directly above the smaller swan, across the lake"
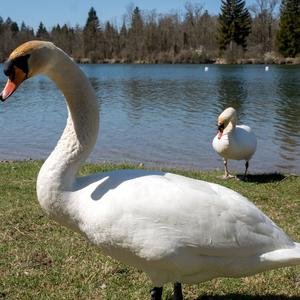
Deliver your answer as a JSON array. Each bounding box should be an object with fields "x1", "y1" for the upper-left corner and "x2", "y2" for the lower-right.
[{"x1": 219, "y1": 0, "x2": 251, "y2": 50}]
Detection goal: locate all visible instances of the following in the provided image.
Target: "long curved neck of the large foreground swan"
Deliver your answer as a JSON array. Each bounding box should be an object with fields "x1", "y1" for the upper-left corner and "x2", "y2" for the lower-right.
[{"x1": 37, "y1": 48, "x2": 99, "y2": 192}]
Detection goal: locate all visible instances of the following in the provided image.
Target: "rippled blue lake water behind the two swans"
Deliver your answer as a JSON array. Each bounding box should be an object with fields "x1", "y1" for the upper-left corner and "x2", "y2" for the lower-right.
[{"x1": 0, "y1": 65, "x2": 300, "y2": 174}]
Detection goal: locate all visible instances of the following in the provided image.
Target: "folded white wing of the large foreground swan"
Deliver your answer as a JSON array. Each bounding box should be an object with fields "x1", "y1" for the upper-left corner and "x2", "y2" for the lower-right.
[{"x1": 74, "y1": 170, "x2": 293, "y2": 259}]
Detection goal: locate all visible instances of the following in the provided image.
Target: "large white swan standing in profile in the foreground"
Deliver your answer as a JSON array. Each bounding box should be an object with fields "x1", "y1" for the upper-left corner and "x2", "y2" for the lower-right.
[{"x1": 0, "y1": 41, "x2": 300, "y2": 300}]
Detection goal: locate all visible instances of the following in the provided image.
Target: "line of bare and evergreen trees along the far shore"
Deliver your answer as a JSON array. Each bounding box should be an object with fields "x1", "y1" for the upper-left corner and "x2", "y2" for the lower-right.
[{"x1": 0, "y1": 0, "x2": 300, "y2": 63}]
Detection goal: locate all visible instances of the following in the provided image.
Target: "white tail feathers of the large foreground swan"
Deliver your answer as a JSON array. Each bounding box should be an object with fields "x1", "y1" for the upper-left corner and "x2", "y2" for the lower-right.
[{"x1": 260, "y1": 243, "x2": 300, "y2": 266}]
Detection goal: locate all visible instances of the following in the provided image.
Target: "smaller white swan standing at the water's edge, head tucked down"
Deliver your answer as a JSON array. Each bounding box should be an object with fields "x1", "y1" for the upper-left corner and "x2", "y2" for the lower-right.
[{"x1": 212, "y1": 107, "x2": 257, "y2": 178}]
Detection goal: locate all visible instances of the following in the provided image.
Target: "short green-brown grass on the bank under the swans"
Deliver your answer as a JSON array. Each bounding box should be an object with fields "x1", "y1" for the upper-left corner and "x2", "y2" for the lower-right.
[{"x1": 0, "y1": 161, "x2": 300, "y2": 300}]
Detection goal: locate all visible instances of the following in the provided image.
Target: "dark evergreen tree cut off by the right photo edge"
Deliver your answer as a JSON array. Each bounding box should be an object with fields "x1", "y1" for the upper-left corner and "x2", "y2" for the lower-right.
[{"x1": 277, "y1": 0, "x2": 300, "y2": 57}]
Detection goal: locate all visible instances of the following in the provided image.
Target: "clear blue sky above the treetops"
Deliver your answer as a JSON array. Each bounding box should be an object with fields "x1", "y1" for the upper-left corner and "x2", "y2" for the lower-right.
[{"x1": 0, "y1": 0, "x2": 255, "y2": 29}]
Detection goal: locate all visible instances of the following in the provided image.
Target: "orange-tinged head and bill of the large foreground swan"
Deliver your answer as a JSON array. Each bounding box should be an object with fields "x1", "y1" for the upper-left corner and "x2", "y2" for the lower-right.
[{"x1": 0, "y1": 41, "x2": 55, "y2": 101}]
